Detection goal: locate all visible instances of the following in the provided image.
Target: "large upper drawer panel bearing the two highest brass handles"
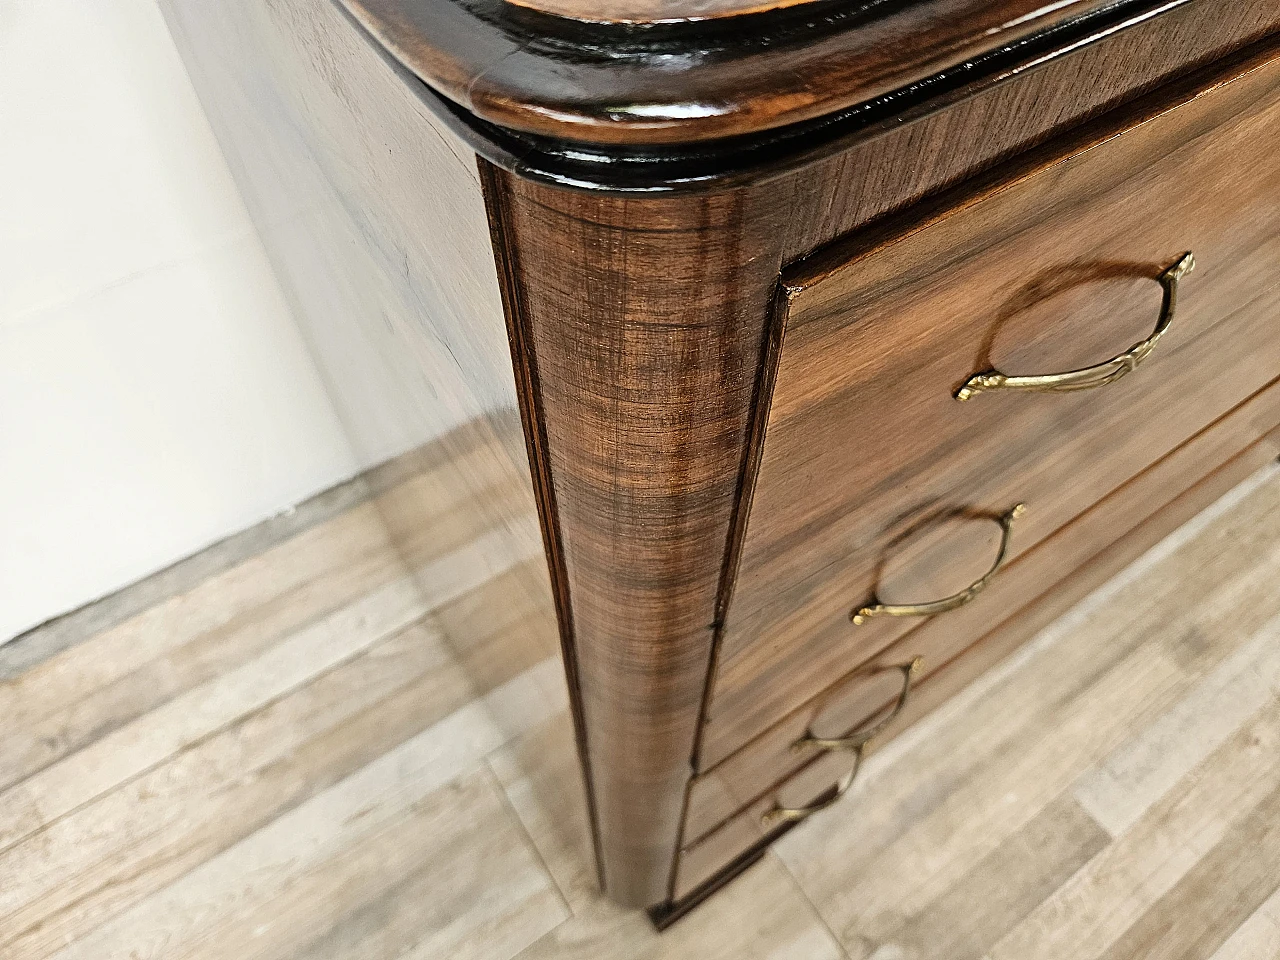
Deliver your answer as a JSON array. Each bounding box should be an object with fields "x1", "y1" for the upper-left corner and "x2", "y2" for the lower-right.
[{"x1": 699, "y1": 47, "x2": 1280, "y2": 769}]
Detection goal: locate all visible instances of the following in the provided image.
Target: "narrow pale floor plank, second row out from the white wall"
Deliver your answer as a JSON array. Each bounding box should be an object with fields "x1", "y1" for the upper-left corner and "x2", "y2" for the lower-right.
[{"x1": 0, "y1": 579, "x2": 426, "y2": 855}]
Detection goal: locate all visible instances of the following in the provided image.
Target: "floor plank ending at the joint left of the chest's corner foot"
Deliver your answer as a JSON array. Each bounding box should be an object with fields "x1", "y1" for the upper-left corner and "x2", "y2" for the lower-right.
[{"x1": 171, "y1": 768, "x2": 568, "y2": 960}]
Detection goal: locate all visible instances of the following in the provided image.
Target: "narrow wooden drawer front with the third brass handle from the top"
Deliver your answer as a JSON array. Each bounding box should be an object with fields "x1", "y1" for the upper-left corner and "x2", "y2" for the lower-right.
[{"x1": 684, "y1": 381, "x2": 1280, "y2": 856}]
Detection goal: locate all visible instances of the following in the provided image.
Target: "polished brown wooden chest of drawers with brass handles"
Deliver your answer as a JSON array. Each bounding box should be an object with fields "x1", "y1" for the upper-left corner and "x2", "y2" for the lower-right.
[{"x1": 165, "y1": 0, "x2": 1280, "y2": 923}]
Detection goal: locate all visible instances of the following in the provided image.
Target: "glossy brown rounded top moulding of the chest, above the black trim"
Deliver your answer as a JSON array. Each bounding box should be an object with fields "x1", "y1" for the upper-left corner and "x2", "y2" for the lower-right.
[{"x1": 339, "y1": 0, "x2": 1141, "y2": 147}]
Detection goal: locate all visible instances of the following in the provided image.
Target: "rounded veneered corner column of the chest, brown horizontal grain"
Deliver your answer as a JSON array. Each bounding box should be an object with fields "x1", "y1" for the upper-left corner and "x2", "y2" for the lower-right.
[{"x1": 483, "y1": 173, "x2": 785, "y2": 905}]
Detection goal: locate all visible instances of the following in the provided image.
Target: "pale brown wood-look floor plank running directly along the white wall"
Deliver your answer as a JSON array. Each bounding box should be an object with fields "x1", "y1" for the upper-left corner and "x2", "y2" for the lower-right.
[{"x1": 0, "y1": 506, "x2": 403, "y2": 788}]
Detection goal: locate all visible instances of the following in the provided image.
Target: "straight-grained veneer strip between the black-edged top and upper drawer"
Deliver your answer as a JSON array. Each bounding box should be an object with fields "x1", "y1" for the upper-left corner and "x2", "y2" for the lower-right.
[{"x1": 776, "y1": 0, "x2": 1280, "y2": 264}]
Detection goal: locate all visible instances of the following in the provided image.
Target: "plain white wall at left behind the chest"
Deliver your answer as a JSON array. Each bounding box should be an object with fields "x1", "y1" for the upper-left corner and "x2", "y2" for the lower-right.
[{"x1": 0, "y1": 0, "x2": 357, "y2": 643}]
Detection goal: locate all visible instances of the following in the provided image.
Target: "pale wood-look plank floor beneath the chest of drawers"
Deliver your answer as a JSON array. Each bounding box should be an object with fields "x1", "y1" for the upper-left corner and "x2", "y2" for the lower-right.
[{"x1": 0, "y1": 468, "x2": 1280, "y2": 960}]
